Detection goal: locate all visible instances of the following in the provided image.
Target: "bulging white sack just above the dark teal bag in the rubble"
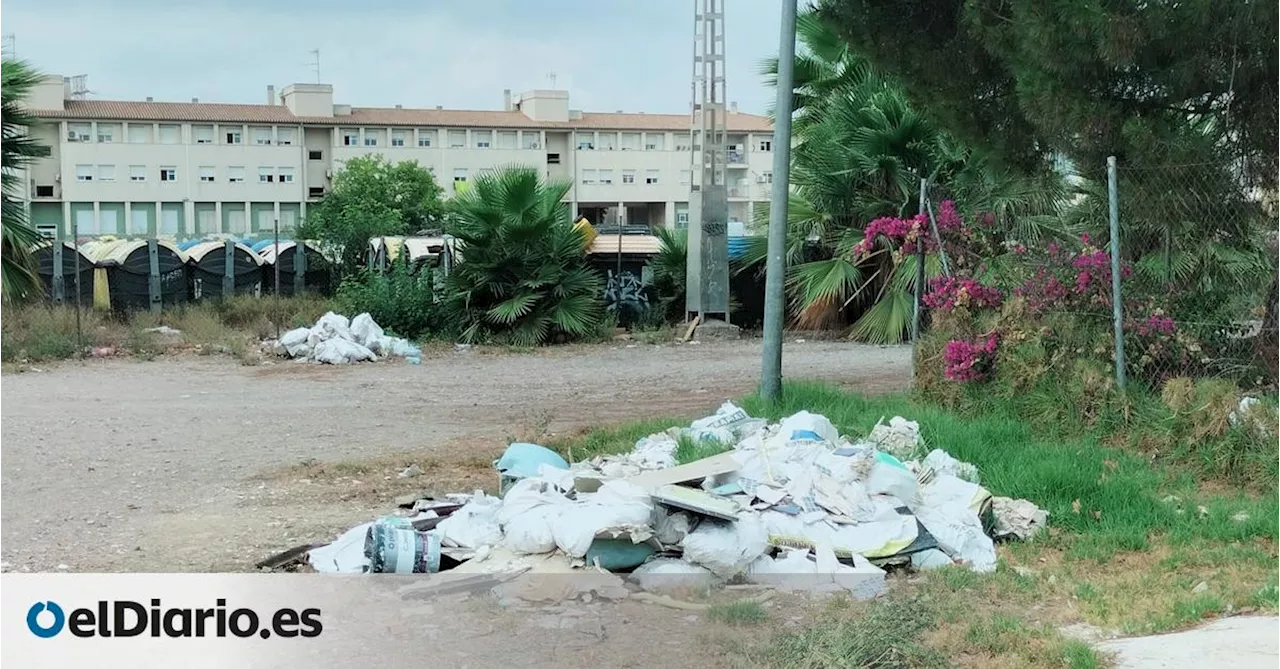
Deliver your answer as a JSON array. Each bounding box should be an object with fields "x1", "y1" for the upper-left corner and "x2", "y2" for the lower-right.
[{"x1": 552, "y1": 480, "x2": 653, "y2": 558}]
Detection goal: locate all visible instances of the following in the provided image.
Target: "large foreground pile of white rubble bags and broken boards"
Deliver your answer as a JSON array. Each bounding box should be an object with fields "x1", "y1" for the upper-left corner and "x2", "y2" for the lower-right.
[{"x1": 308, "y1": 403, "x2": 1047, "y2": 597}]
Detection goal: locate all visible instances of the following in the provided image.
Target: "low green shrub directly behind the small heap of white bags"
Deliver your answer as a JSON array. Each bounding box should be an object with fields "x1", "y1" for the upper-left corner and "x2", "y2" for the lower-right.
[{"x1": 338, "y1": 261, "x2": 445, "y2": 339}]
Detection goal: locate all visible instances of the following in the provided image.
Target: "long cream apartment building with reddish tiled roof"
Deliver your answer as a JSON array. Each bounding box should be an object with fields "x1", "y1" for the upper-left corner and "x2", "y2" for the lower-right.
[{"x1": 22, "y1": 77, "x2": 772, "y2": 239}]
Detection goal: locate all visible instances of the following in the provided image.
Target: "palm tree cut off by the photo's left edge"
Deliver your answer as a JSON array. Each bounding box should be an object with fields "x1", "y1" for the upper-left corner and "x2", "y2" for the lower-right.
[{"x1": 0, "y1": 59, "x2": 49, "y2": 303}]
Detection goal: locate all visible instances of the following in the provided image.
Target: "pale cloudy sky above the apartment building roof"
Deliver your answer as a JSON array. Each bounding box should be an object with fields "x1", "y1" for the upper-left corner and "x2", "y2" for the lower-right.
[{"x1": 0, "y1": 0, "x2": 781, "y2": 114}]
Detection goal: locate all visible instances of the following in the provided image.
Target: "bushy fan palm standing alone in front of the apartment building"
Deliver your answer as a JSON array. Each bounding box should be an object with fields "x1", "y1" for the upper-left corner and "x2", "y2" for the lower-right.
[{"x1": 445, "y1": 166, "x2": 602, "y2": 345}]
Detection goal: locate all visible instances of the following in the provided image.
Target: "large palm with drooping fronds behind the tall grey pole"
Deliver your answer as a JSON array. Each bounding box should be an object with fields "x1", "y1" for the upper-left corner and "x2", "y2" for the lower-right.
[{"x1": 744, "y1": 10, "x2": 1061, "y2": 343}]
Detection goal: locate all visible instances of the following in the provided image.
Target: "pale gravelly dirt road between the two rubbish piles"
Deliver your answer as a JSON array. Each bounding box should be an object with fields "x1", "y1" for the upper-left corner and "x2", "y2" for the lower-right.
[{"x1": 0, "y1": 340, "x2": 910, "y2": 572}]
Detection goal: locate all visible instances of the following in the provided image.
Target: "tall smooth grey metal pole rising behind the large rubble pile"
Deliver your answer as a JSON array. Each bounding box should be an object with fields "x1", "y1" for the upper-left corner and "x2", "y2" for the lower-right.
[{"x1": 760, "y1": 0, "x2": 796, "y2": 403}]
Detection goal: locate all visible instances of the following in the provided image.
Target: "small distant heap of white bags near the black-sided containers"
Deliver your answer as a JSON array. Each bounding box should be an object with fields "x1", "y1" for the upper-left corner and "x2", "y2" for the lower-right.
[{"x1": 262, "y1": 311, "x2": 422, "y2": 365}]
